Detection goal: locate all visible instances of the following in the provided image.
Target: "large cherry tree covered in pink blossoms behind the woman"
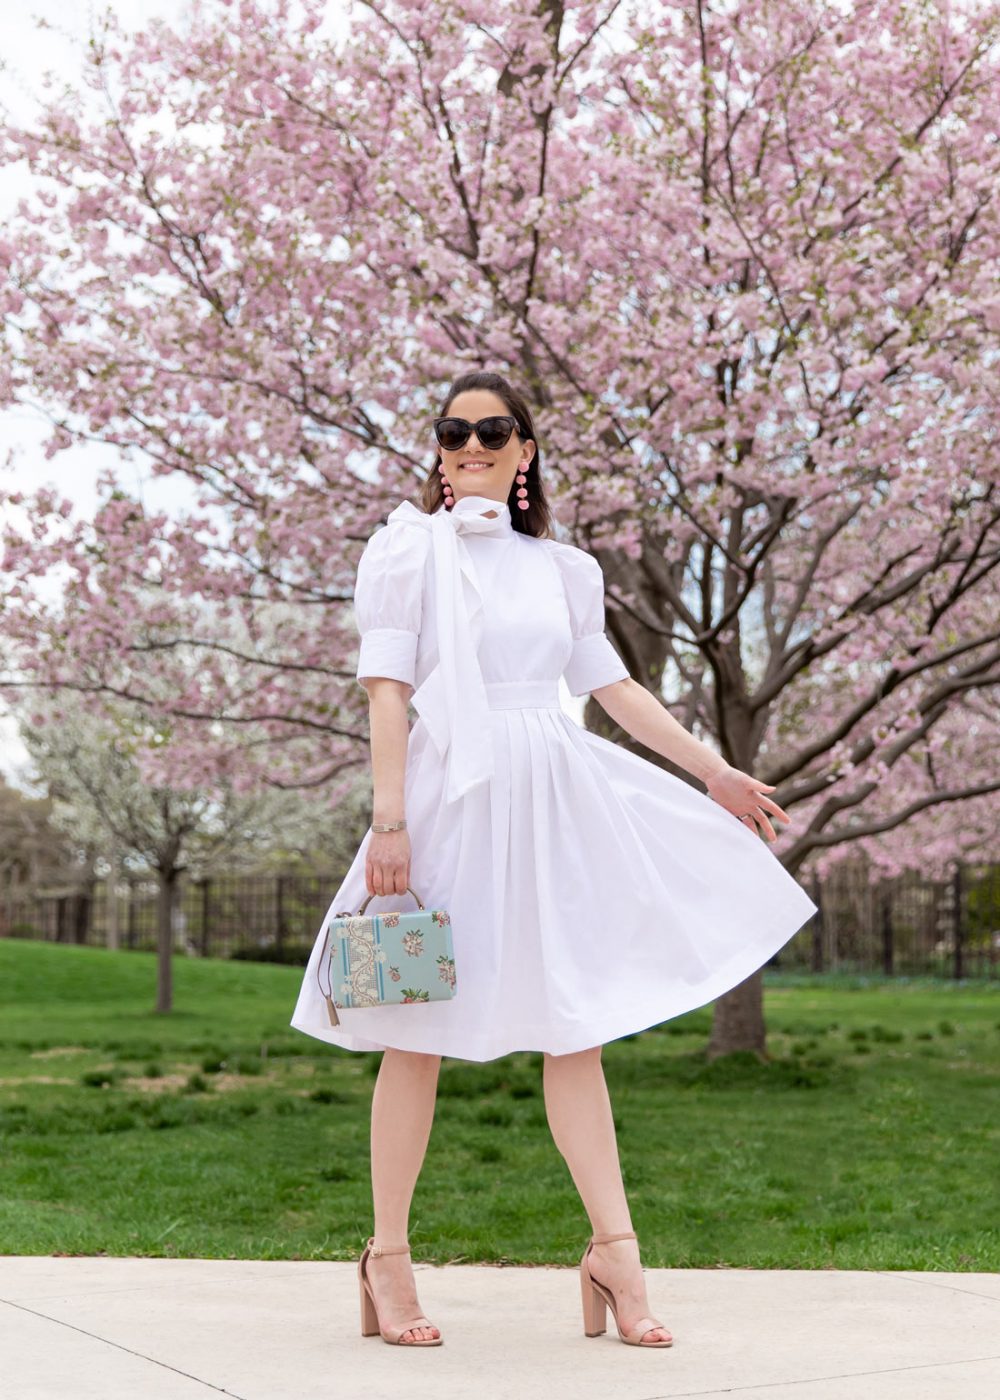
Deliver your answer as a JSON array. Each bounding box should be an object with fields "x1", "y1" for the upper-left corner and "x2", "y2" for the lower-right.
[{"x1": 0, "y1": 0, "x2": 1000, "y2": 1053}]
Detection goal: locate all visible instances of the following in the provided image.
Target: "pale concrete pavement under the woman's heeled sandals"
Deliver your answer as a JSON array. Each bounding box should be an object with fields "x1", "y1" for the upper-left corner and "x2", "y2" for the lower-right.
[{"x1": 0, "y1": 1256, "x2": 1000, "y2": 1400}]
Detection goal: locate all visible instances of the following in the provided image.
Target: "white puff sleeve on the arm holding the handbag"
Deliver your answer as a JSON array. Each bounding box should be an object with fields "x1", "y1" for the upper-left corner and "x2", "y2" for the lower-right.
[{"x1": 354, "y1": 525, "x2": 429, "y2": 689}]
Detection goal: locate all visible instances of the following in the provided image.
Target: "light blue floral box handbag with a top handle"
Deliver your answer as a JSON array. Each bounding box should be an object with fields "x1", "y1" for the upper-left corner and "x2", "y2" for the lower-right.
[{"x1": 317, "y1": 885, "x2": 455, "y2": 1026}]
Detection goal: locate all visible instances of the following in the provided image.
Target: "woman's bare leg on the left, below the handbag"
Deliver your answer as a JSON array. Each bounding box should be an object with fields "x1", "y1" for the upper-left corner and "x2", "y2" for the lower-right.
[{"x1": 367, "y1": 1049, "x2": 441, "y2": 1343}]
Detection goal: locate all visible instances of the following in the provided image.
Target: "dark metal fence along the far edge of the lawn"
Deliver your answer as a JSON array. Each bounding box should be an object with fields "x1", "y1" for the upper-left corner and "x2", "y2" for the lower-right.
[{"x1": 0, "y1": 862, "x2": 1000, "y2": 979}]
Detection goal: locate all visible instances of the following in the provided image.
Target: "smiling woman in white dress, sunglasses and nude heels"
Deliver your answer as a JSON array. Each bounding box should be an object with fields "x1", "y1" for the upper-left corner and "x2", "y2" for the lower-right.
[{"x1": 284, "y1": 372, "x2": 815, "y2": 1347}]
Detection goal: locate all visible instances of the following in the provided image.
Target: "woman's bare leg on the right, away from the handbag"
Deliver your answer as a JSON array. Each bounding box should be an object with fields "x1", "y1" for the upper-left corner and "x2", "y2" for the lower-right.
[{"x1": 542, "y1": 1046, "x2": 671, "y2": 1343}]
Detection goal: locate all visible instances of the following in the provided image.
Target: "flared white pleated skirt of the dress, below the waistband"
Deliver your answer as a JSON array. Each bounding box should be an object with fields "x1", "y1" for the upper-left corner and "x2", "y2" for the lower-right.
[{"x1": 284, "y1": 680, "x2": 817, "y2": 1061}]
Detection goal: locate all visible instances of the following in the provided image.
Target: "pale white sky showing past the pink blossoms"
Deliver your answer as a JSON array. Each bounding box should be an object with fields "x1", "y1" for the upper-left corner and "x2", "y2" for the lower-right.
[{"x1": 0, "y1": 0, "x2": 583, "y2": 784}]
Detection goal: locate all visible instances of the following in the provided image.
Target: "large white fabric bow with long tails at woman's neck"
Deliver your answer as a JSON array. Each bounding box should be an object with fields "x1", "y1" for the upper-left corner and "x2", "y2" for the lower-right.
[{"x1": 387, "y1": 496, "x2": 513, "y2": 802}]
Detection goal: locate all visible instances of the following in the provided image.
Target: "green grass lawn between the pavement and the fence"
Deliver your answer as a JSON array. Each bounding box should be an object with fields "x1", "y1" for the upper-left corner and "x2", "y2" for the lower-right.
[{"x1": 0, "y1": 941, "x2": 1000, "y2": 1271}]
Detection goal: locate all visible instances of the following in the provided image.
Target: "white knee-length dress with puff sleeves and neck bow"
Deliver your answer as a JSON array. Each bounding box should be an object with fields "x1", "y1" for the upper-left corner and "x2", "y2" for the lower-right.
[{"x1": 285, "y1": 497, "x2": 817, "y2": 1061}]
